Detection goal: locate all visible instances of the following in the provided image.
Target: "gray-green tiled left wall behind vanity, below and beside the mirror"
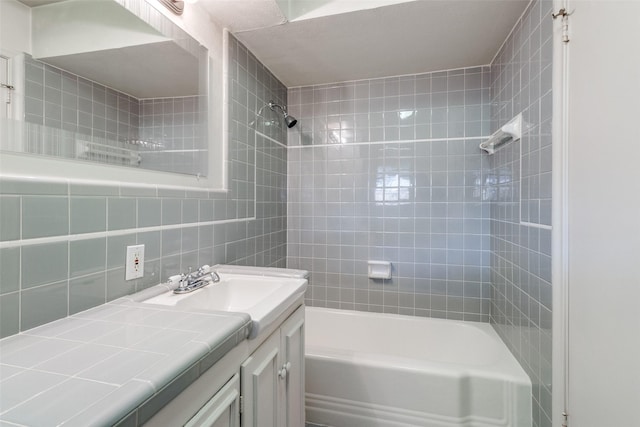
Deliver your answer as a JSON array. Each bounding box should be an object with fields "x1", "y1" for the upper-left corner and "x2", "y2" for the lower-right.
[{"x1": 0, "y1": 36, "x2": 287, "y2": 337}]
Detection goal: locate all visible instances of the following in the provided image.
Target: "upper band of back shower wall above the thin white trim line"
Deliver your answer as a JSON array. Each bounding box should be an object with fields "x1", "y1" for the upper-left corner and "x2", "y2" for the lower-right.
[{"x1": 289, "y1": 67, "x2": 491, "y2": 146}]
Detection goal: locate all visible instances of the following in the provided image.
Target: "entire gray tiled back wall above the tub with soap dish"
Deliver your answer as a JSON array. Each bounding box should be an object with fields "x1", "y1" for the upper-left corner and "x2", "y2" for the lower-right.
[{"x1": 287, "y1": 67, "x2": 490, "y2": 321}]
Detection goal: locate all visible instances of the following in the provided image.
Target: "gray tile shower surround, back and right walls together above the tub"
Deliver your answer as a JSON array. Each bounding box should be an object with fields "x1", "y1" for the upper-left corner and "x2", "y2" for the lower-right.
[{"x1": 287, "y1": 0, "x2": 553, "y2": 427}]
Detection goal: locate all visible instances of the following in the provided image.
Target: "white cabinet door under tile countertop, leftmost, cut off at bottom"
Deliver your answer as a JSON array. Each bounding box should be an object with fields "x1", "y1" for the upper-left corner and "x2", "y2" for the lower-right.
[{"x1": 185, "y1": 374, "x2": 240, "y2": 427}]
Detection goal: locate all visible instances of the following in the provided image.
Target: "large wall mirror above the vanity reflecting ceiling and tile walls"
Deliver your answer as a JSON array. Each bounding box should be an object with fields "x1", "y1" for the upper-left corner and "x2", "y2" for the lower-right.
[{"x1": 0, "y1": 0, "x2": 209, "y2": 177}]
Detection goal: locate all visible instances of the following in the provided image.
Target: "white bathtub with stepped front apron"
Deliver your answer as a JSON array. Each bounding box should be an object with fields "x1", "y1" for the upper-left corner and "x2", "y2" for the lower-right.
[{"x1": 305, "y1": 307, "x2": 531, "y2": 427}]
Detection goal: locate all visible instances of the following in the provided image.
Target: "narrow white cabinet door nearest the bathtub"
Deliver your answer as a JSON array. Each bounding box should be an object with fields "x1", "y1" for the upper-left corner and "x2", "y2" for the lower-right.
[{"x1": 280, "y1": 307, "x2": 305, "y2": 427}]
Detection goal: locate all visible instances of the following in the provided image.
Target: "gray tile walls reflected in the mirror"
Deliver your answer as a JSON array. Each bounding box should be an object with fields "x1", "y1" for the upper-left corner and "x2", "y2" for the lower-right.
[{"x1": 25, "y1": 56, "x2": 207, "y2": 176}]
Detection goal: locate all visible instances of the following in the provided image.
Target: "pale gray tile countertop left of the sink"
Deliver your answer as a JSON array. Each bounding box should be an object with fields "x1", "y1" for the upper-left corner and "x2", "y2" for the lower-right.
[{"x1": 0, "y1": 285, "x2": 251, "y2": 427}]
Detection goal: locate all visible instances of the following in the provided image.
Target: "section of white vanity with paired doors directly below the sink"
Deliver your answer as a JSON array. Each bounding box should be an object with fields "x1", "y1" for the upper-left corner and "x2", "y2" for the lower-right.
[{"x1": 240, "y1": 306, "x2": 304, "y2": 427}]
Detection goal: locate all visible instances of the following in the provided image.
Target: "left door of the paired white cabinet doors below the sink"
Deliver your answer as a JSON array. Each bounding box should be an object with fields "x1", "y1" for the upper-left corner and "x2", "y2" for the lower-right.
[{"x1": 240, "y1": 331, "x2": 282, "y2": 427}]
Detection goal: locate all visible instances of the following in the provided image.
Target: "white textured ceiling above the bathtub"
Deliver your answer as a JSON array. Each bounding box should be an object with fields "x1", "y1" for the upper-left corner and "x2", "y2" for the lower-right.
[{"x1": 201, "y1": 0, "x2": 529, "y2": 87}]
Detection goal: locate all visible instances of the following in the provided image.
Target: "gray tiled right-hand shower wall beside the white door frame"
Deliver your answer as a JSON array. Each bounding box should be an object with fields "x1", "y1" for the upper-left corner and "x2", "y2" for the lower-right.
[{"x1": 489, "y1": 0, "x2": 553, "y2": 427}]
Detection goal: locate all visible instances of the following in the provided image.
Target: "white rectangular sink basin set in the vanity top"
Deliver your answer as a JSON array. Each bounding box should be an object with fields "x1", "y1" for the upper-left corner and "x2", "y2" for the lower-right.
[{"x1": 141, "y1": 272, "x2": 307, "y2": 339}]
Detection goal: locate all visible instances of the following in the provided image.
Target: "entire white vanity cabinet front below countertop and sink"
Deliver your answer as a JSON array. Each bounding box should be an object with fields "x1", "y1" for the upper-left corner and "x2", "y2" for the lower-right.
[{"x1": 144, "y1": 305, "x2": 305, "y2": 427}]
